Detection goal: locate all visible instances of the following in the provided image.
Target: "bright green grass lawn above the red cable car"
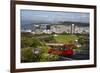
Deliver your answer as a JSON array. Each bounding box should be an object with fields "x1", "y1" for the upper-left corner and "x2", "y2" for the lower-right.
[{"x1": 54, "y1": 35, "x2": 78, "y2": 43}]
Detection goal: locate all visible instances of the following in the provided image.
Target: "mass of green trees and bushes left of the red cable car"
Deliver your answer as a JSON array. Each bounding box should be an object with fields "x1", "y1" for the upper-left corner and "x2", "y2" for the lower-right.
[{"x1": 21, "y1": 36, "x2": 59, "y2": 62}]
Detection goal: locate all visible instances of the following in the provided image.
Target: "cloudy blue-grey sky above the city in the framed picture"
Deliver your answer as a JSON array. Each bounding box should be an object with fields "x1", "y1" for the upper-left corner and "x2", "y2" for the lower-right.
[{"x1": 21, "y1": 10, "x2": 90, "y2": 24}]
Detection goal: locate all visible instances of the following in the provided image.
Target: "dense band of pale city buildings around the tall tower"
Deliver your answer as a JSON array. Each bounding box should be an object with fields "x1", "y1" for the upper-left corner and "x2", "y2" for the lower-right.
[{"x1": 50, "y1": 24, "x2": 89, "y2": 34}]
